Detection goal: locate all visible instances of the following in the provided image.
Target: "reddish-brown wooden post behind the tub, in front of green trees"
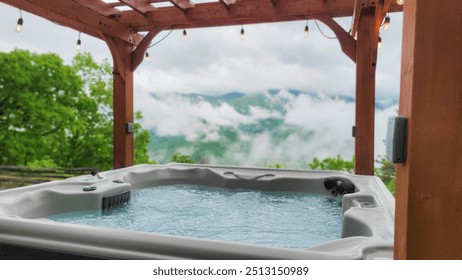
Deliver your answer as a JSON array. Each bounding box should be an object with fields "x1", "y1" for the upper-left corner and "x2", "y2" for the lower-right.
[{"x1": 104, "y1": 37, "x2": 133, "y2": 168}]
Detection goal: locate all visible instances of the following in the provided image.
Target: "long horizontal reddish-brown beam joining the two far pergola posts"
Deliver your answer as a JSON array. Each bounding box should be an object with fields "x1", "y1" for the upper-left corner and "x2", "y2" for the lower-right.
[{"x1": 119, "y1": 0, "x2": 401, "y2": 31}]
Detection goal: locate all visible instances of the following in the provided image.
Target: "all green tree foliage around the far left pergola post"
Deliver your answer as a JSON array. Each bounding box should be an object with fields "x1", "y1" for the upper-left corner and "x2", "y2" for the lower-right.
[{"x1": 0, "y1": 50, "x2": 149, "y2": 169}]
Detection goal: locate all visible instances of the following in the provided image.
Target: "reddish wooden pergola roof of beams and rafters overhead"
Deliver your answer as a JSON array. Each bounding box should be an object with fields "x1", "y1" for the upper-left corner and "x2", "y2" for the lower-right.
[{"x1": 0, "y1": 0, "x2": 402, "y2": 46}]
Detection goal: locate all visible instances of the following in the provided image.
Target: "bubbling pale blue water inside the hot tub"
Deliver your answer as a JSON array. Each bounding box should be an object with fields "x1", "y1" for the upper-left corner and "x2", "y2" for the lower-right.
[{"x1": 49, "y1": 185, "x2": 342, "y2": 248}]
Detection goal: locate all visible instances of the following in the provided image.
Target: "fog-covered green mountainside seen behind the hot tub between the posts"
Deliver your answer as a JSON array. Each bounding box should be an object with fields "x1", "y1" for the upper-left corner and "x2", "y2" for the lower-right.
[{"x1": 139, "y1": 89, "x2": 397, "y2": 168}]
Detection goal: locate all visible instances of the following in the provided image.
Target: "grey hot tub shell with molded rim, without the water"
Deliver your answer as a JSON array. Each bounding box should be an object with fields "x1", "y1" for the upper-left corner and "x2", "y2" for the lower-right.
[{"x1": 0, "y1": 164, "x2": 394, "y2": 259}]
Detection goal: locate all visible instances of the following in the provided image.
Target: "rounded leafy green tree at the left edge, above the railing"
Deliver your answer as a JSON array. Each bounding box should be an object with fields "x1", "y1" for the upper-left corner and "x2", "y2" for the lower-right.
[{"x1": 0, "y1": 50, "x2": 82, "y2": 165}]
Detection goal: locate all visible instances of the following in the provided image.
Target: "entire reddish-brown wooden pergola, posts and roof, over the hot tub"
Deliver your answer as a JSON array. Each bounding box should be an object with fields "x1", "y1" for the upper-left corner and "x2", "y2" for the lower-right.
[{"x1": 0, "y1": 0, "x2": 462, "y2": 259}]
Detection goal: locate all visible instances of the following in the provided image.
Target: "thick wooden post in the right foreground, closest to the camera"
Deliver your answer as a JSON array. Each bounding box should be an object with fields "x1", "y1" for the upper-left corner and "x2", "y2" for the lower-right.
[{"x1": 394, "y1": 0, "x2": 462, "y2": 259}]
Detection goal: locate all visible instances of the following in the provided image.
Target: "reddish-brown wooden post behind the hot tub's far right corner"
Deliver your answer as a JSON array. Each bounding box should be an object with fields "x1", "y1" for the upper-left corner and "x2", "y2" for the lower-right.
[{"x1": 355, "y1": 7, "x2": 378, "y2": 175}]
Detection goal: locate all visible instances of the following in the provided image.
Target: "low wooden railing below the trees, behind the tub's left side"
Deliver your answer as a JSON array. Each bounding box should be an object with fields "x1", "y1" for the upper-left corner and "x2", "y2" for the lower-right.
[{"x1": 0, "y1": 165, "x2": 99, "y2": 190}]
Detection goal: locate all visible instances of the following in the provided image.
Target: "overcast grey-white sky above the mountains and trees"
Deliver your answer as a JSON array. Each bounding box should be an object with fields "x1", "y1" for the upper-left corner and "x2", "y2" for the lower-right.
[{"x1": 0, "y1": 4, "x2": 402, "y2": 162}]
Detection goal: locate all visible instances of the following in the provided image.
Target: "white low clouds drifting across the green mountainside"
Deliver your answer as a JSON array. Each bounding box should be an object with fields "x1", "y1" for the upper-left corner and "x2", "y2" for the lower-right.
[{"x1": 134, "y1": 91, "x2": 396, "y2": 168}]
